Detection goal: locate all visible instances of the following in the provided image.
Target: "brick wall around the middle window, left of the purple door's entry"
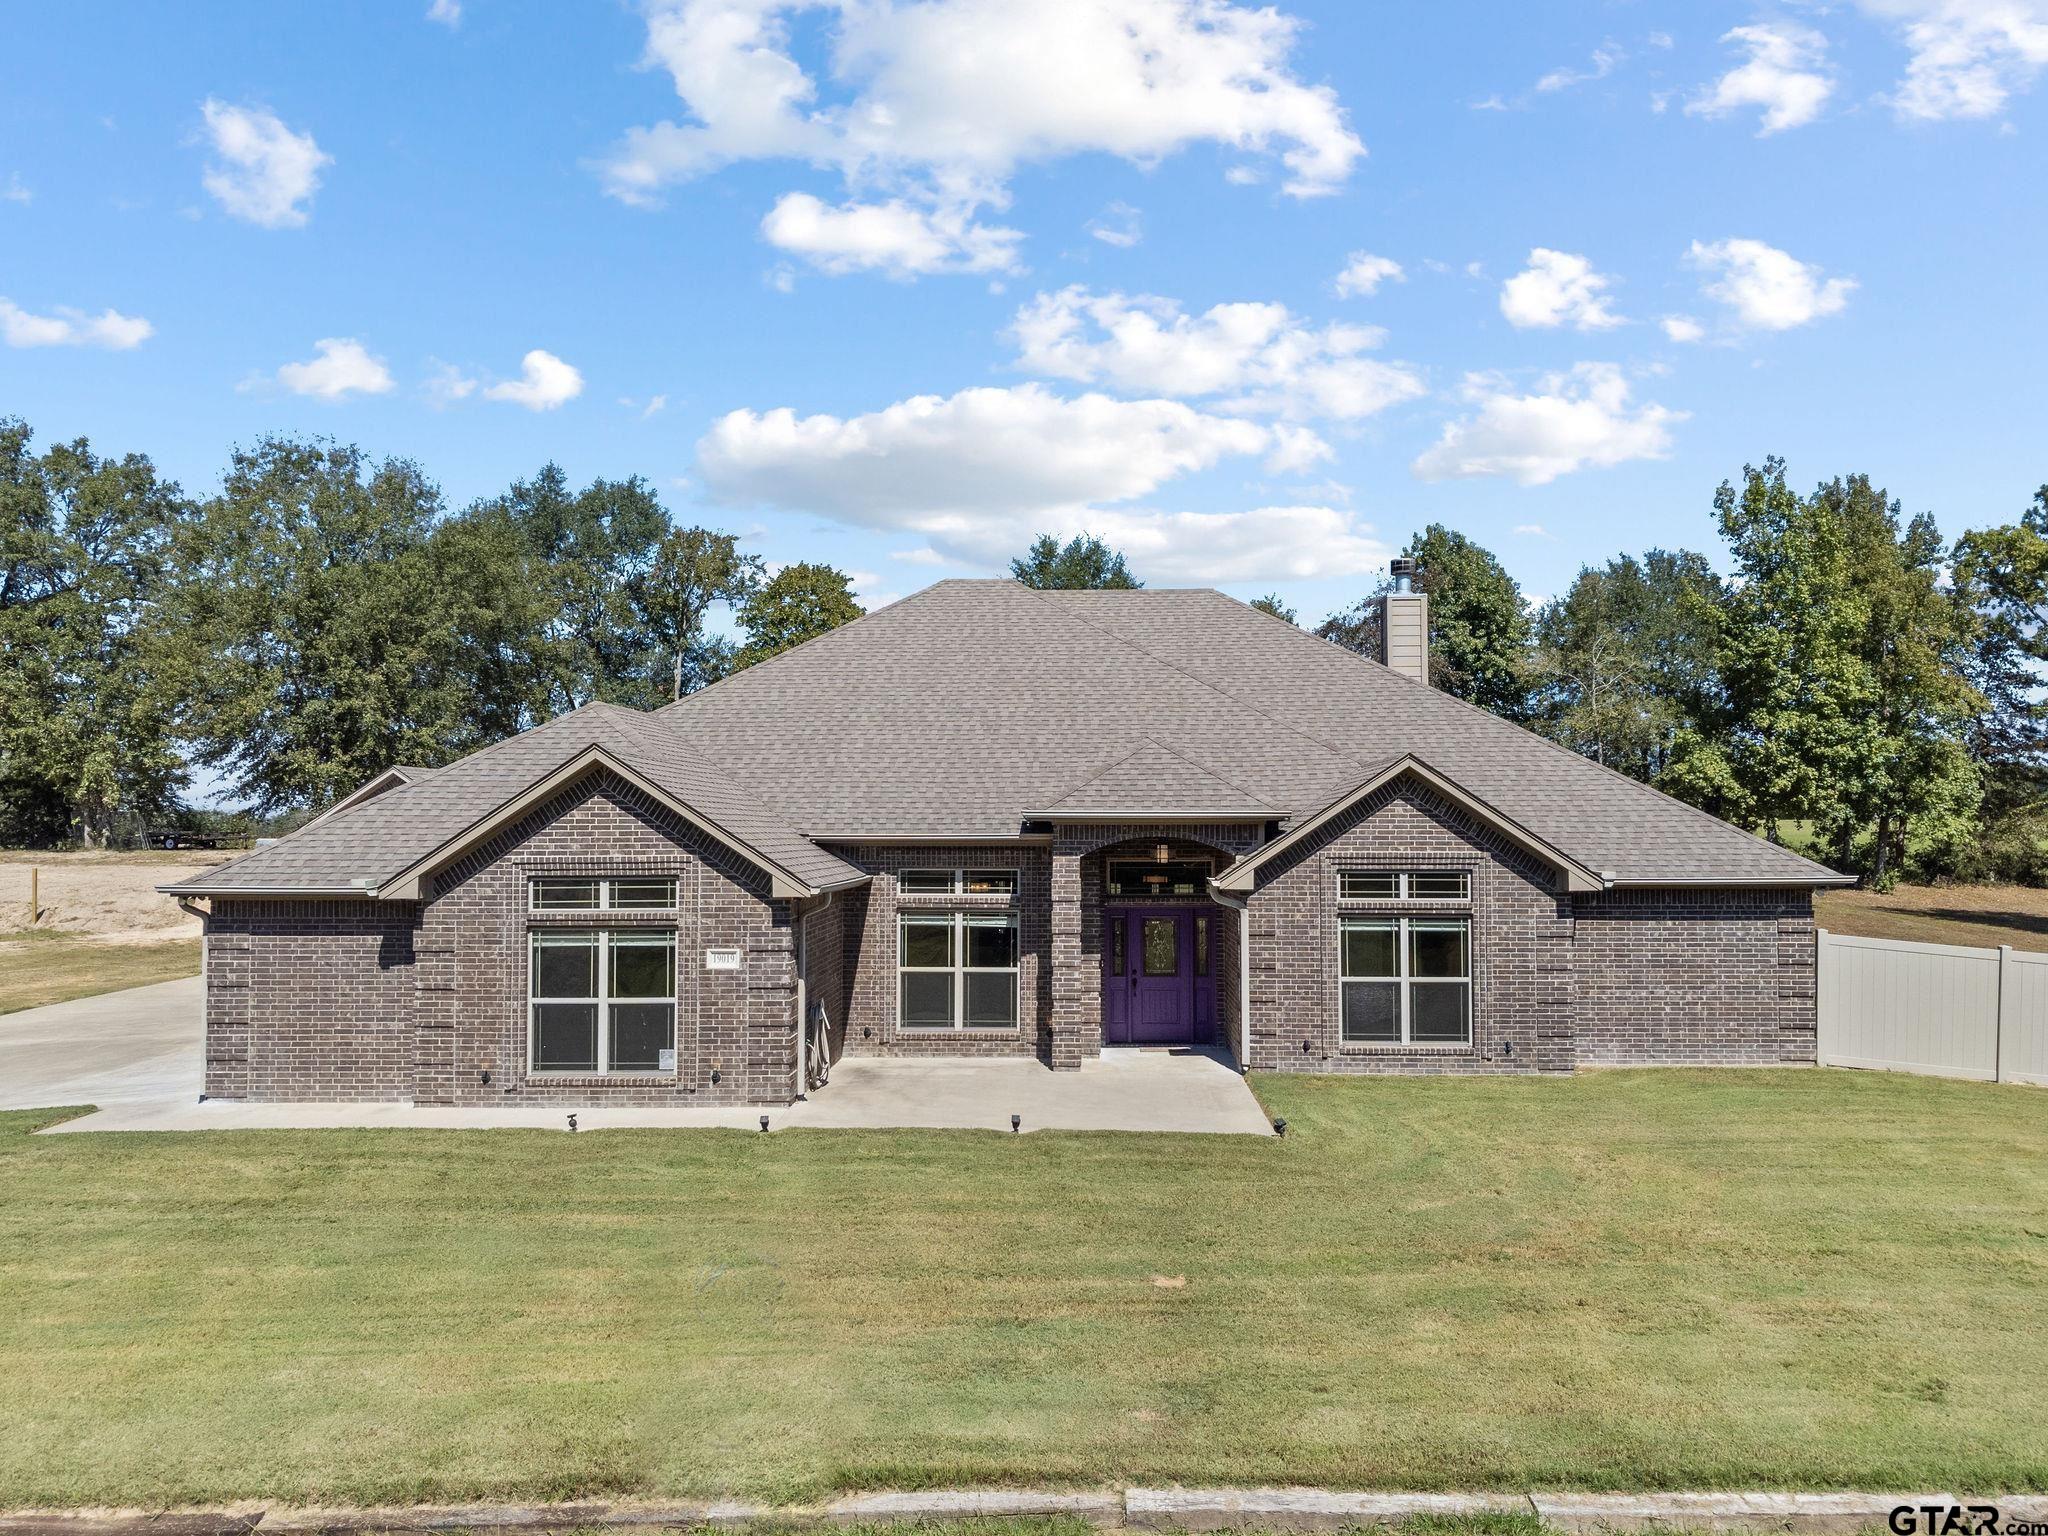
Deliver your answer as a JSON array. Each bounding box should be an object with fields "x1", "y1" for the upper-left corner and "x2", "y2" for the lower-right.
[{"x1": 831, "y1": 844, "x2": 1053, "y2": 1057}]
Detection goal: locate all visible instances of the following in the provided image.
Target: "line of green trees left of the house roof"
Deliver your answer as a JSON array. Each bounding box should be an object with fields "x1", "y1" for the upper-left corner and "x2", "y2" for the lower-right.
[{"x1": 0, "y1": 420, "x2": 860, "y2": 846}]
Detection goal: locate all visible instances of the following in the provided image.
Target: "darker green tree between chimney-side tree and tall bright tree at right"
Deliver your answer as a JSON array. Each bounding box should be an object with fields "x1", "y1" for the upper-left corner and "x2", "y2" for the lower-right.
[{"x1": 1532, "y1": 549, "x2": 1720, "y2": 780}]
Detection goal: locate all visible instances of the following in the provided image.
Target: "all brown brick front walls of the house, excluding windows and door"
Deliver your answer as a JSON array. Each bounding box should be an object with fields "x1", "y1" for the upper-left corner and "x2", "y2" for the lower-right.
[{"x1": 207, "y1": 778, "x2": 1815, "y2": 1104}]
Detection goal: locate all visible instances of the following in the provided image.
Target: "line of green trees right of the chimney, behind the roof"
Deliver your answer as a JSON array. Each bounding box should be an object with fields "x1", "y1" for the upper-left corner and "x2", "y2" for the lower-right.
[{"x1": 1319, "y1": 459, "x2": 2048, "y2": 885}]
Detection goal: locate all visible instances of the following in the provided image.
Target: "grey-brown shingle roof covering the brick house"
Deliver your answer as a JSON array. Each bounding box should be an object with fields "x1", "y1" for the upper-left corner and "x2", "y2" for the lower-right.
[{"x1": 174, "y1": 582, "x2": 1837, "y2": 893}]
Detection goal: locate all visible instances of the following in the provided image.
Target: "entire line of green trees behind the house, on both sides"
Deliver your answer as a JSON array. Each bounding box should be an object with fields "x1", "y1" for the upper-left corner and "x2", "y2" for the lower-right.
[{"x1": 0, "y1": 420, "x2": 2048, "y2": 885}]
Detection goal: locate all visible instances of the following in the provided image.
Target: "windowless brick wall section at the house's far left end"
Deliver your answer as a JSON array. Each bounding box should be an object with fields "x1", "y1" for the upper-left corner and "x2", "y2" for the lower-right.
[{"x1": 205, "y1": 899, "x2": 418, "y2": 1102}]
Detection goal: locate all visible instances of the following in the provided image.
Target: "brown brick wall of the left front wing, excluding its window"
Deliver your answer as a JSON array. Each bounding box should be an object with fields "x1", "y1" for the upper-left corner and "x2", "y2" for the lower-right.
[{"x1": 207, "y1": 774, "x2": 797, "y2": 1104}]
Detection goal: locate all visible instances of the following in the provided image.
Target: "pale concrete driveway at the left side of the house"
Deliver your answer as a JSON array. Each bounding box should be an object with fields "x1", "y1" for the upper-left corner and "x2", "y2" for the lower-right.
[{"x1": 0, "y1": 977, "x2": 205, "y2": 1110}]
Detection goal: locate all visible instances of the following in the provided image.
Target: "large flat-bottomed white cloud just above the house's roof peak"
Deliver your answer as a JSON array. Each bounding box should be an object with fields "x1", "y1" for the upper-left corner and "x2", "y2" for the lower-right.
[{"x1": 696, "y1": 385, "x2": 1386, "y2": 582}]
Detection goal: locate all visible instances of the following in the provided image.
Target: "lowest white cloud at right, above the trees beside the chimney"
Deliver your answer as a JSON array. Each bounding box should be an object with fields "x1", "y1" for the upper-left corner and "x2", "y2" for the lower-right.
[{"x1": 1413, "y1": 362, "x2": 1686, "y2": 485}]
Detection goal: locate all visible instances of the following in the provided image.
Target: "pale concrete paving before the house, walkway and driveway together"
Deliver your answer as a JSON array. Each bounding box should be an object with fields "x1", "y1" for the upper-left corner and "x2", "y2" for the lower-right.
[{"x1": 16, "y1": 977, "x2": 1272, "y2": 1137}]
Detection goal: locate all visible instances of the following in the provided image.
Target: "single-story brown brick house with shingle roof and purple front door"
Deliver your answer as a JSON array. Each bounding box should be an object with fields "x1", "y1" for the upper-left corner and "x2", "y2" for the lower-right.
[{"x1": 164, "y1": 582, "x2": 1843, "y2": 1104}]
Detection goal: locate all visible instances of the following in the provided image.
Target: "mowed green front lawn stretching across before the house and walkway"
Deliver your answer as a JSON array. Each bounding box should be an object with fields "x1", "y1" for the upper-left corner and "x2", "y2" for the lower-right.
[{"x1": 0, "y1": 1069, "x2": 2048, "y2": 1507}]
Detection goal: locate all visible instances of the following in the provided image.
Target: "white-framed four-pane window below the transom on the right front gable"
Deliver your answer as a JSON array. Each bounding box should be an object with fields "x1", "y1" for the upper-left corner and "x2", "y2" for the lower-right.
[{"x1": 1337, "y1": 918, "x2": 1473, "y2": 1044}]
